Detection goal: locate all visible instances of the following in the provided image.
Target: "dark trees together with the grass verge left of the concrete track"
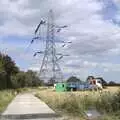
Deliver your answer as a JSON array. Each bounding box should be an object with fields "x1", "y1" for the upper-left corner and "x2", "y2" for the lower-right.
[{"x1": 0, "y1": 53, "x2": 42, "y2": 112}]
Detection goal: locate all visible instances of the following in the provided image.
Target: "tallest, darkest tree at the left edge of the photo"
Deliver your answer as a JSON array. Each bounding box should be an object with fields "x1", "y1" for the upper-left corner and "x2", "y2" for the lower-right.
[{"x1": 0, "y1": 53, "x2": 19, "y2": 89}]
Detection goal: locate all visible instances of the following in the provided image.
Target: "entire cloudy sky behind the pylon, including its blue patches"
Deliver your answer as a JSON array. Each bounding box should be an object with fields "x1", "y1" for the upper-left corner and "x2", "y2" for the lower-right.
[{"x1": 0, "y1": 0, "x2": 120, "y2": 82}]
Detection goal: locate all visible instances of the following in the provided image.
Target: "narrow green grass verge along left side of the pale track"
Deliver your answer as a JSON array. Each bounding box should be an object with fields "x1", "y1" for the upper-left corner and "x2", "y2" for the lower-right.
[{"x1": 0, "y1": 90, "x2": 15, "y2": 113}]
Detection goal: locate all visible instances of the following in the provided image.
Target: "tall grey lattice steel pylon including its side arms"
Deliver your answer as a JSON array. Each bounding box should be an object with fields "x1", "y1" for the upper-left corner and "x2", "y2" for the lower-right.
[{"x1": 32, "y1": 10, "x2": 67, "y2": 84}]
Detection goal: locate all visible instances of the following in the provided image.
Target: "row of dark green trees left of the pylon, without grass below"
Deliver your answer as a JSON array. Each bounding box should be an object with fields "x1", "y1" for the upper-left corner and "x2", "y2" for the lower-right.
[{"x1": 0, "y1": 53, "x2": 42, "y2": 90}]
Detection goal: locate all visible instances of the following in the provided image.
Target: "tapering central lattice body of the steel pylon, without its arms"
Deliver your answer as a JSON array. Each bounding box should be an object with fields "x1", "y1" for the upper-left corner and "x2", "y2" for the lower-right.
[{"x1": 40, "y1": 10, "x2": 63, "y2": 83}]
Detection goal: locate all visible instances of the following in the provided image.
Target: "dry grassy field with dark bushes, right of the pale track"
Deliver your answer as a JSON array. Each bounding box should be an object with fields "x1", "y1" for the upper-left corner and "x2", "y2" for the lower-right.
[{"x1": 36, "y1": 87, "x2": 120, "y2": 120}]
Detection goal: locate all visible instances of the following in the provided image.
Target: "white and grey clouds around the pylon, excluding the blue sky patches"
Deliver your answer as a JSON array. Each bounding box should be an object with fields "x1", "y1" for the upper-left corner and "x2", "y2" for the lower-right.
[{"x1": 0, "y1": 0, "x2": 120, "y2": 81}]
